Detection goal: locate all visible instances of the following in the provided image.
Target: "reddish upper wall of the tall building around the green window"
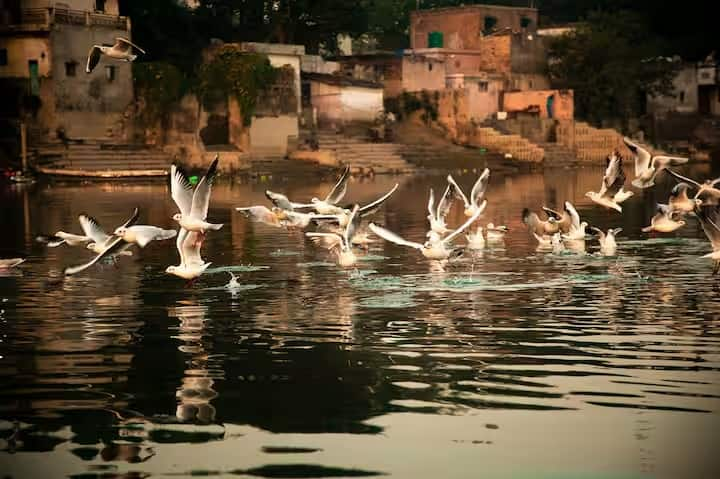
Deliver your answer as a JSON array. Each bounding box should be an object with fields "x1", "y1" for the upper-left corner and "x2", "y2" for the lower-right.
[{"x1": 410, "y1": 5, "x2": 538, "y2": 49}]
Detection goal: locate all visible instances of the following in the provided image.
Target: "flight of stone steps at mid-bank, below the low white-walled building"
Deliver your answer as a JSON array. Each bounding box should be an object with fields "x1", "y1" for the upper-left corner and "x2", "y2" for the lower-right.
[{"x1": 317, "y1": 132, "x2": 413, "y2": 174}]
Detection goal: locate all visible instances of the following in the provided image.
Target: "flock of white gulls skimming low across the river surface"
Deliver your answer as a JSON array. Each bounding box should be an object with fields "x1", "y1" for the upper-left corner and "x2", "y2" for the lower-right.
[{"x1": 0, "y1": 138, "x2": 720, "y2": 280}]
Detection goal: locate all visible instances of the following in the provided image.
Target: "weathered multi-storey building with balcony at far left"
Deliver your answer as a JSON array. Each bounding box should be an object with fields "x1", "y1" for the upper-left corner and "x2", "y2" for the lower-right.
[{"x1": 0, "y1": 0, "x2": 133, "y2": 140}]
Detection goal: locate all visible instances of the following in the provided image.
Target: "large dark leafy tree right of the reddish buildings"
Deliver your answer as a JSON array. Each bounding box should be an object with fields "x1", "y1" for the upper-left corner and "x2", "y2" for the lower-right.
[{"x1": 549, "y1": 11, "x2": 676, "y2": 126}]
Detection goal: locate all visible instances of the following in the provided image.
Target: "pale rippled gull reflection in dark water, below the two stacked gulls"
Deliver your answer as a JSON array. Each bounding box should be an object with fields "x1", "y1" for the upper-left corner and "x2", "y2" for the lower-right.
[{"x1": 168, "y1": 304, "x2": 218, "y2": 424}]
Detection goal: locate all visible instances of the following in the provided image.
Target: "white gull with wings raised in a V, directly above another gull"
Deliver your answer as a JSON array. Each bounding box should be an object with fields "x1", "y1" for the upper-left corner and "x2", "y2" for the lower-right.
[{"x1": 170, "y1": 155, "x2": 223, "y2": 233}]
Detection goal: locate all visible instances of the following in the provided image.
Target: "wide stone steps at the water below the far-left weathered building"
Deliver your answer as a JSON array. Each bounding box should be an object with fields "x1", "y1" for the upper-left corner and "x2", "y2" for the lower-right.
[{"x1": 29, "y1": 140, "x2": 172, "y2": 177}]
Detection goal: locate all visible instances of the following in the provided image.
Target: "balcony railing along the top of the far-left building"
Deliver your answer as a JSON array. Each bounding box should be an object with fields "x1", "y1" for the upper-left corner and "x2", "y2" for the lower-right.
[{"x1": 0, "y1": 8, "x2": 130, "y2": 31}]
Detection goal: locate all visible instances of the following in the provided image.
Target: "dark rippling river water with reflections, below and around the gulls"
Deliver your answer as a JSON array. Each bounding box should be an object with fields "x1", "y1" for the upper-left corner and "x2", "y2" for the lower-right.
[{"x1": 0, "y1": 166, "x2": 720, "y2": 478}]
